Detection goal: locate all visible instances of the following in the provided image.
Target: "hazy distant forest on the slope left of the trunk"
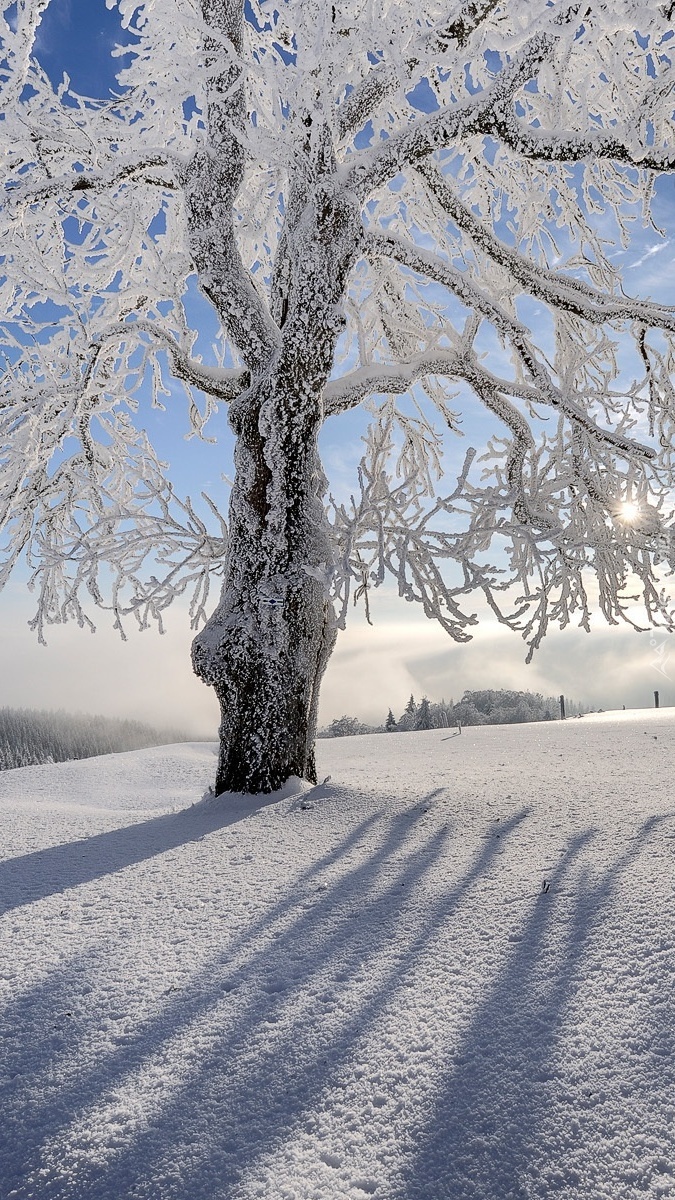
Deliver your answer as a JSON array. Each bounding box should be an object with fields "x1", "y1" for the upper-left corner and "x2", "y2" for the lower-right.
[{"x1": 0, "y1": 708, "x2": 186, "y2": 770}]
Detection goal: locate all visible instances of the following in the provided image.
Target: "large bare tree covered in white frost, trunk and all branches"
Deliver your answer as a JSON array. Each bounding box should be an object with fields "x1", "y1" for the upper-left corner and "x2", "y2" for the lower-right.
[{"x1": 0, "y1": 0, "x2": 675, "y2": 792}]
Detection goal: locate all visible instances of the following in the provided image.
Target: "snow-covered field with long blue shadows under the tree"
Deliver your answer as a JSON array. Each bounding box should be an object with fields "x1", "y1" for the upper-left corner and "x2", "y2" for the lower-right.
[{"x1": 0, "y1": 709, "x2": 675, "y2": 1200}]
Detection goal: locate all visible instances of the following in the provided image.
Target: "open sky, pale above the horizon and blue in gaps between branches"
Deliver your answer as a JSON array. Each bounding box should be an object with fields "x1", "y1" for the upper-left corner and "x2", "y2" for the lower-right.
[{"x1": 0, "y1": 0, "x2": 675, "y2": 732}]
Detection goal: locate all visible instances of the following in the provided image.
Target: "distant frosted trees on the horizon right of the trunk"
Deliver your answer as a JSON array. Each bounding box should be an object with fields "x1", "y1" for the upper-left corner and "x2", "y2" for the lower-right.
[{"x1": 318, "y1": 689, "x2": 587, "y2": 738}]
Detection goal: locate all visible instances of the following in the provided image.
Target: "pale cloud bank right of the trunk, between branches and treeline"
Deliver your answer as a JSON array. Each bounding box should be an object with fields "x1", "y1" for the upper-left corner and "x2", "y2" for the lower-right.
[{"x1": 321, "y1": 597, "x2": 675, "y2": 724}]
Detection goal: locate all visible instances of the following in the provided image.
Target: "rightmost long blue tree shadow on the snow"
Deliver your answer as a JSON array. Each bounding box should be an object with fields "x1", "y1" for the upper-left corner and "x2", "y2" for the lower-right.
[{"x1": 393, "y1": 817, "x2": 665, "y2": 1200}]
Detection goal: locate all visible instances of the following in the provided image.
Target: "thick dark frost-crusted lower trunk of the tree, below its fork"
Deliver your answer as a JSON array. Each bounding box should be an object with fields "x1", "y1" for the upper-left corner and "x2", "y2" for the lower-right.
[{"x1": 192, "y1": 362, "x2": 336, "y2": 796}]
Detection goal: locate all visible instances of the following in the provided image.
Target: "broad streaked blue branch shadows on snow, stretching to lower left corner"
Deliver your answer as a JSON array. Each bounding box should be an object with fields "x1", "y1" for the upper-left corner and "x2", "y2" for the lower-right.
[{"x1": 0, "y1": 809, "x2": 526, "y2": 1200}]
